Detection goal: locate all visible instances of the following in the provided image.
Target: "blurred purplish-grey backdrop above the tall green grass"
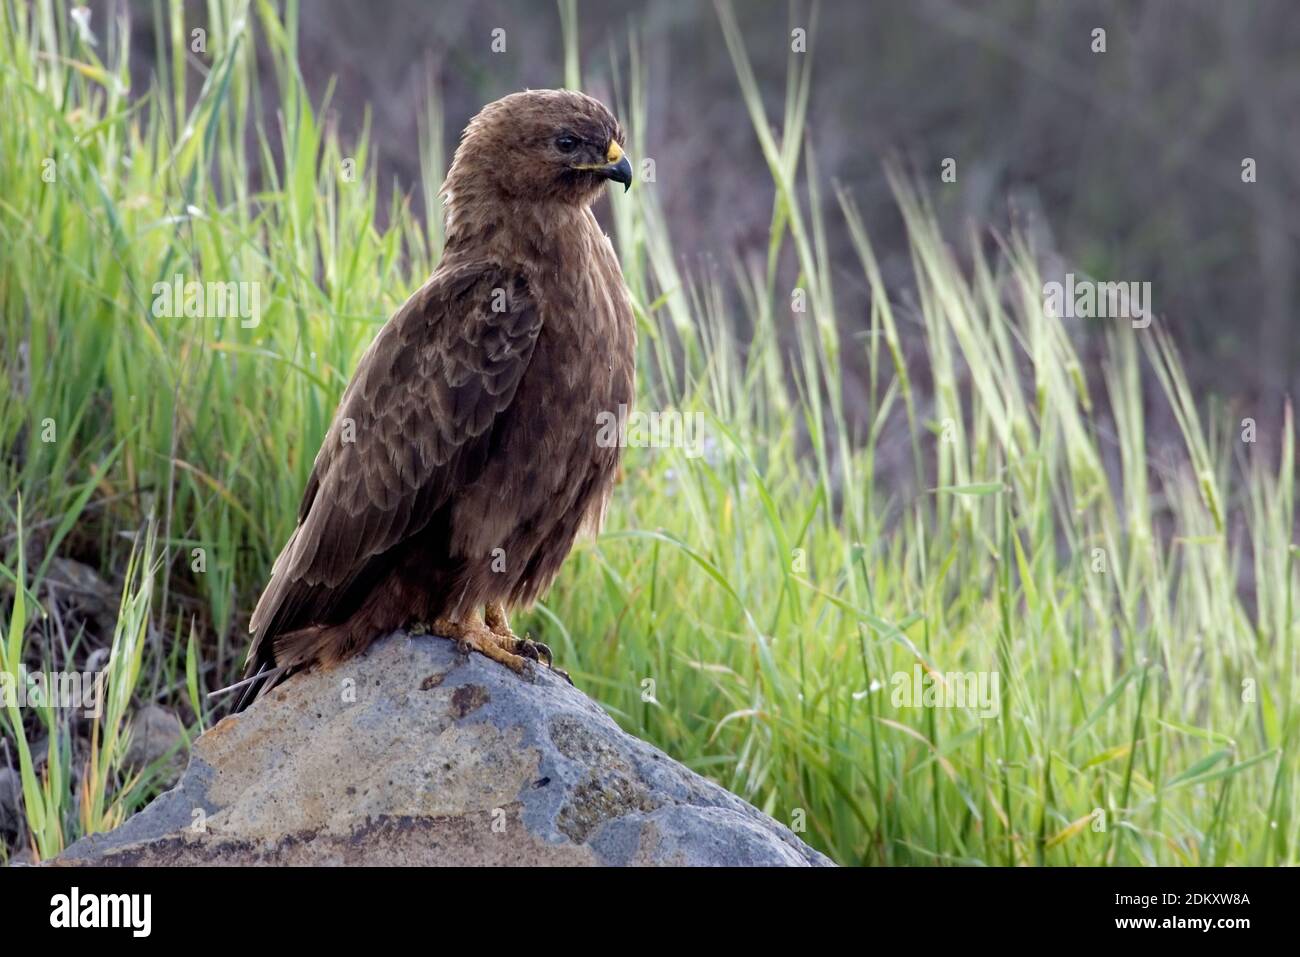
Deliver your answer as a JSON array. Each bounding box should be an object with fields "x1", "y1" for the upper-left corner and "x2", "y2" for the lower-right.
[{"x1": 124, "y1": 0, "x2": 1300, "y2": 425}]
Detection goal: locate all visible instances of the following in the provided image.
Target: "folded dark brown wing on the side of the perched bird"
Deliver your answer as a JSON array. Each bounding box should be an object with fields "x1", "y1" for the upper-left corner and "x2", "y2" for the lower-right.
[{"x1": 247, "y1": 261, "x2": 541, "y2": 674}]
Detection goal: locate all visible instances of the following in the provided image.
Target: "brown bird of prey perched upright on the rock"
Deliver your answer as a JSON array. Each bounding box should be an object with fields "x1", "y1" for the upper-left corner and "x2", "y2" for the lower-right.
[{"x1": 239, "y1": 90, "x2": 636, "y2": 707}]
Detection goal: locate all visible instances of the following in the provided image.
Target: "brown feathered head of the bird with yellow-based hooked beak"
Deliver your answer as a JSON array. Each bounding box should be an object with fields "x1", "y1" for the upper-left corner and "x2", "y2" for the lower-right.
[{"x1": 445, "y1": 90, "x2": 632, "y2": 205}]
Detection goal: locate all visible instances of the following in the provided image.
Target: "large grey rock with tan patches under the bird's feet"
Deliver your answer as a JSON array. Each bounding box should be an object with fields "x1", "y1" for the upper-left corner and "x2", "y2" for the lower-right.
[{"x1": 56, "y1": 633, "x2": 831, "y2": 866}]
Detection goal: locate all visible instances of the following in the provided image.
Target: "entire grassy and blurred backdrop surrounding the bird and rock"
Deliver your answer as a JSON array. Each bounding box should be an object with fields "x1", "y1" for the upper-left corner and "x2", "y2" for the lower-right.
[{"x1": 0, "y1": 0, "x2": 1300, "y2": 865}]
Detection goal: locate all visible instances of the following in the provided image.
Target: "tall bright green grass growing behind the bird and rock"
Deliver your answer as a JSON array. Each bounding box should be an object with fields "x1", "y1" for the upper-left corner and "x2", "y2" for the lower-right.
[{"x1": 0, "y1": 0, "x2": 1300, "y2": 865}]
